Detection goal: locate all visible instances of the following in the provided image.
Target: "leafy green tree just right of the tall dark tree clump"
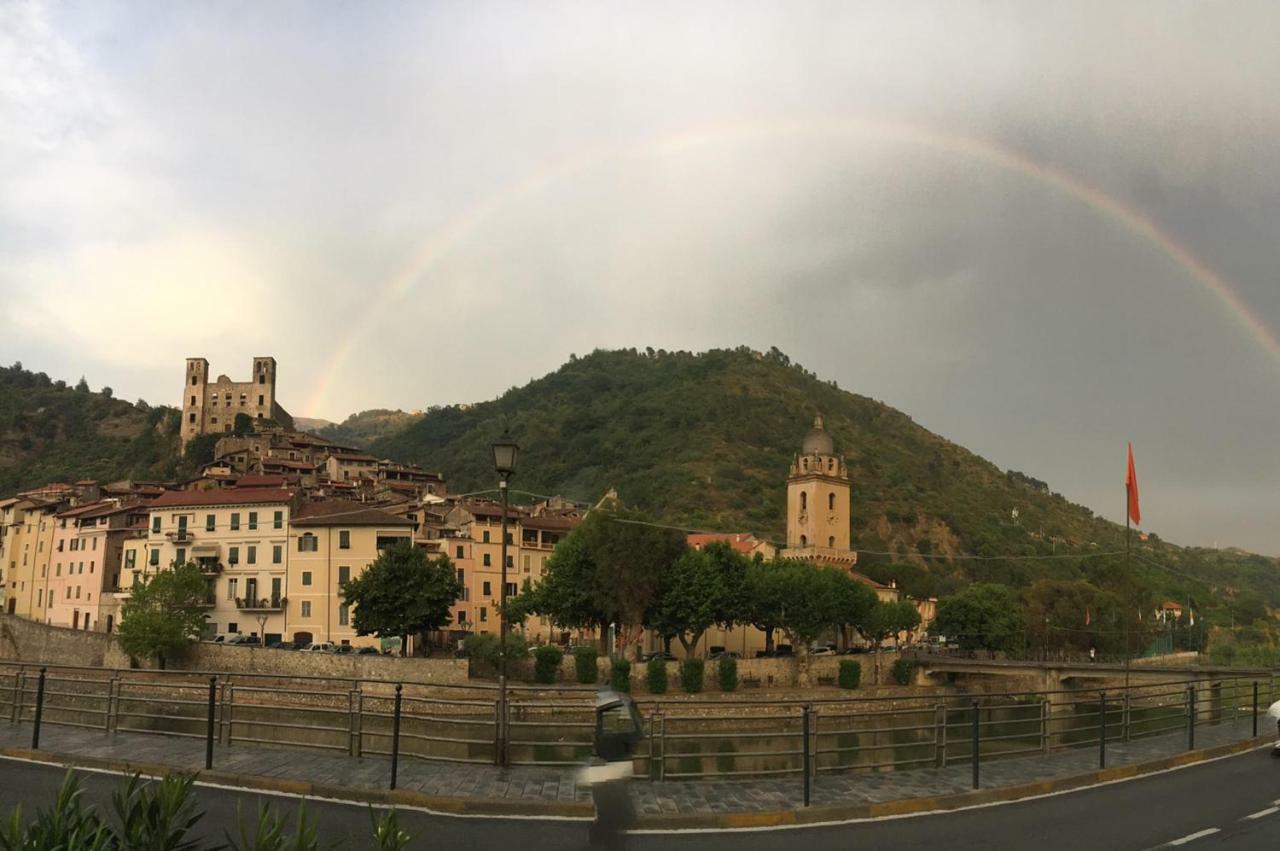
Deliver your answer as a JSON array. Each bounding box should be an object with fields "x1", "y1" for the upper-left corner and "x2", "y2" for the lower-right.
[{"x1": 646, "y1": 543, "x2": 746, "y2": 655}]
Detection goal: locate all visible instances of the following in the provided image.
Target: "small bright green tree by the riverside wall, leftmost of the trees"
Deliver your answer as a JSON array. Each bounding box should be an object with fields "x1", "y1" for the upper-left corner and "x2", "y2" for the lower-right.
[{"x1": 118, "y1": 563, "x2": 212, "y2": 668}]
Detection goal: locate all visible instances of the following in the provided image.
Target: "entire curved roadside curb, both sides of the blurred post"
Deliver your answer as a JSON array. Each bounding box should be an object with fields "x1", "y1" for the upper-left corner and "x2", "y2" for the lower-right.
[{"x1": 0, "y1": 736, "x2": 1272, "y2": 831}]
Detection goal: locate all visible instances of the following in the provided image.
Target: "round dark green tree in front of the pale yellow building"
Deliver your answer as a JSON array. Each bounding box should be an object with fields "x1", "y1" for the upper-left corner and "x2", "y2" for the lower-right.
[{"x1": 342, "y1": 543, "x2": 462, "y2": 655}]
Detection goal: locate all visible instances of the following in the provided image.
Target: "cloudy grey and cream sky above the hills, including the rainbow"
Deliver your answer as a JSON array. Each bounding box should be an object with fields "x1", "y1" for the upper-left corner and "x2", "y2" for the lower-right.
[{"x1": 0, "y1": 0, "x2": 1280, "y2": 554}]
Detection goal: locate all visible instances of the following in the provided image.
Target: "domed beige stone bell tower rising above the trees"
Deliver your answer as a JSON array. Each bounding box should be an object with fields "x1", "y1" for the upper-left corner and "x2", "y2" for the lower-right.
[{"x1": 781, "y1": 416, "x2": 858, "y2": 566}]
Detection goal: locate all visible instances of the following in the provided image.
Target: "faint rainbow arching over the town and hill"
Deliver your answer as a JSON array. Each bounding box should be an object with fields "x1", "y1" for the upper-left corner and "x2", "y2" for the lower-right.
[{"x1": 303, "y1": 118, "x2": 1280, "y2": 412}]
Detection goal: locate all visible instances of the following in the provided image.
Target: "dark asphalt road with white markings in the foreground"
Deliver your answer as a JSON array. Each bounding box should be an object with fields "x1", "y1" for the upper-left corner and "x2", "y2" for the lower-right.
[{"x1": 0, "y1": 750, "x2": 1280, "y2": 851}]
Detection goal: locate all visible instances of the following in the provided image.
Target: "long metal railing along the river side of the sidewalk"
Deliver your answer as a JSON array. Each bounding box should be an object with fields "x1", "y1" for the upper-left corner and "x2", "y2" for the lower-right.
[{"x1": 0, "y1": 663, "x2": 1280, "y2": 793}]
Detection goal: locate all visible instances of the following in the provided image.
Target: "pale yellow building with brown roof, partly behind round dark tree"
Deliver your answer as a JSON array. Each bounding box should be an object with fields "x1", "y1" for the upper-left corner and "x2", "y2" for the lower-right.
[{"x1": 285, "y1": 500, "x2": 416, "y2": 648}]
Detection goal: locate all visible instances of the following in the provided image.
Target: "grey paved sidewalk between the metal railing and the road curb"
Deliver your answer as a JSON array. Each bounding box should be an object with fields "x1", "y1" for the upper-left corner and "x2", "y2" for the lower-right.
[{"x1": 0, "y1": 718, "x2": 1270, "y2": 820}]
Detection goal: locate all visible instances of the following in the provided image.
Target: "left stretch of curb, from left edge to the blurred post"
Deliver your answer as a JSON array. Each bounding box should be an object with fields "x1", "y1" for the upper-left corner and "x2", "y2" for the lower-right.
[{"x1": 0, "y1": 747, "x2": 595, "y2": 820}]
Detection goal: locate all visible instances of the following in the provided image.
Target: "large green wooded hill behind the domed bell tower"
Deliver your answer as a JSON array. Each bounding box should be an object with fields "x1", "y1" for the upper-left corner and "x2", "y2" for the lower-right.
[{"x1": 370, "y1": 348, "x2": 1280, "y2": 621}]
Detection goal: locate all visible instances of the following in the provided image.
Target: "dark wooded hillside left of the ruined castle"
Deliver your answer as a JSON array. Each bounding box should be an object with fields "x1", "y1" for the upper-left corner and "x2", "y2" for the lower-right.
[{"x1": 0, "y1": 363, "x2": 179, "y2": 495}]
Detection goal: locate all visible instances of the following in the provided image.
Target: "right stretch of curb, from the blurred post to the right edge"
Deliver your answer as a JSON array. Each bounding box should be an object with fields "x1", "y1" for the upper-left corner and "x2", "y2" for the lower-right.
[{"x1": 631, "y1": 736, "x2": 1274, "y2": 831}]
